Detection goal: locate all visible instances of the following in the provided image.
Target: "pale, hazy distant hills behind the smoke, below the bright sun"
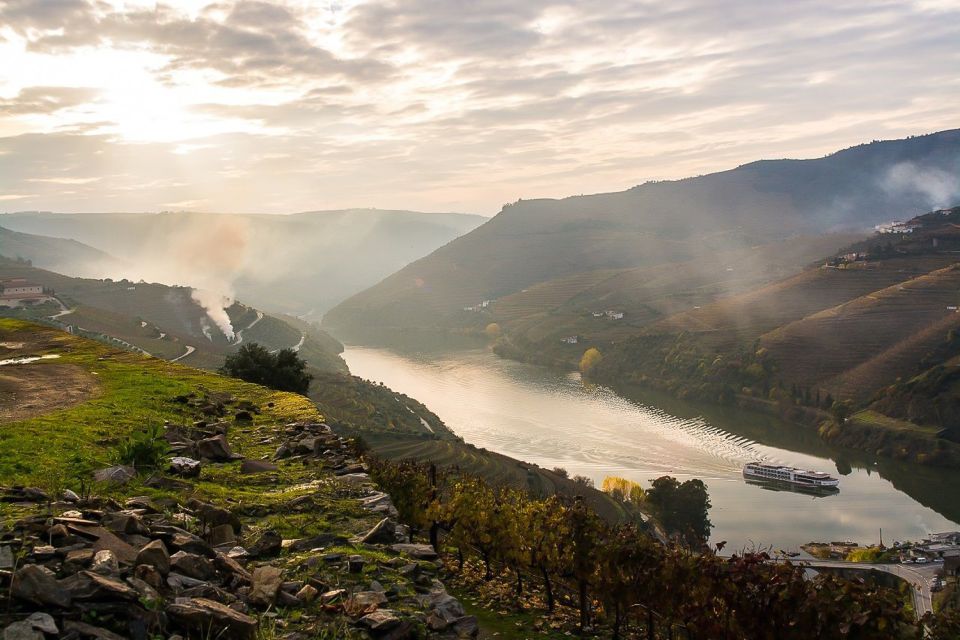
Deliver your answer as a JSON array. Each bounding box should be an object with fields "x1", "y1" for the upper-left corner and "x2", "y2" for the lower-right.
[{"x1": 0, "y1": 209, "x2": 486, "y2": 320}]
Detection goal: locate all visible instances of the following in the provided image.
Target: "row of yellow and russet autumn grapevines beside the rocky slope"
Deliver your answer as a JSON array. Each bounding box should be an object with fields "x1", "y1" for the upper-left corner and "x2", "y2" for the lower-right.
[{"x1": 371, "y1": 460, "x2": 954, "y2": 640}]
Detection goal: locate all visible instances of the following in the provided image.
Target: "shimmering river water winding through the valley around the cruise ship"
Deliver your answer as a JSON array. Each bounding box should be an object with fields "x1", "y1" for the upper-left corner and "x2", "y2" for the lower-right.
[{"x1": 343, "y1": 346, "x2": 960, "y2": 551}]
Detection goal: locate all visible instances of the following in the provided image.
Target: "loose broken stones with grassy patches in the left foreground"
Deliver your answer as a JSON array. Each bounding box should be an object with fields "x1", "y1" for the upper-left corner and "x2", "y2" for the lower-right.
[{"x1": 0, "y1": 393, "x2": 478, "y2": 640}]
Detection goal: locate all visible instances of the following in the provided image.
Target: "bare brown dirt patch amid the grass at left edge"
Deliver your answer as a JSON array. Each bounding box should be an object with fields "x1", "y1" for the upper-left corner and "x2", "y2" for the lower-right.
[{"x1": 0, "y1": 363, "x2": 99, "y2": 424}]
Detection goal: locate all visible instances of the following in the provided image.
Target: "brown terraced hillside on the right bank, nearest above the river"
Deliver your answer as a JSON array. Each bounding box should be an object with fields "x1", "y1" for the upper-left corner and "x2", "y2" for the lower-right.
[{"x1": 592, "y1": 207, "x2": 960, "y2": 466}]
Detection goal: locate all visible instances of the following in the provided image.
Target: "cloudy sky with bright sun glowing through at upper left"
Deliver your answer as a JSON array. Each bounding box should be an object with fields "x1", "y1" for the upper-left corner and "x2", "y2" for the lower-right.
[{"x1": 0, "y1": 0, "x2": 960, "y2": 215}]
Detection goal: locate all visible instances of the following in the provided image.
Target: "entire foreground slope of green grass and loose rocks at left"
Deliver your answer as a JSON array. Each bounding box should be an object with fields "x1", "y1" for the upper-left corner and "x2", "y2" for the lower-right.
[{"x1": 0, "y1": 319, "x2": 496, "y2": 640}]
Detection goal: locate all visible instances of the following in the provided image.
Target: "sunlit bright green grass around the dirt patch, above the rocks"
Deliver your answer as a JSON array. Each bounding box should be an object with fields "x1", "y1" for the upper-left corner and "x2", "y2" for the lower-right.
[{"x1": 0, "y1": 319, "x2": 319, "y2": 486}]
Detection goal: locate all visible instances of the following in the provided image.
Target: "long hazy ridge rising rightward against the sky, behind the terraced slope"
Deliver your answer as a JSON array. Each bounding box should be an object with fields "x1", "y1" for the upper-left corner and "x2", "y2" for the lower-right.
[{"x1": 324, "y1": 130, "x2": 960, "y2": 337}]
